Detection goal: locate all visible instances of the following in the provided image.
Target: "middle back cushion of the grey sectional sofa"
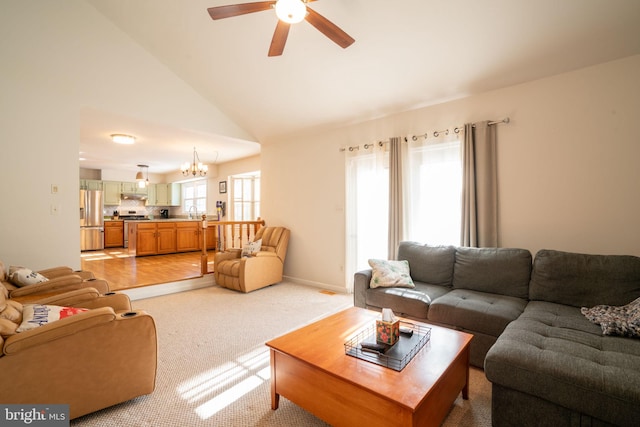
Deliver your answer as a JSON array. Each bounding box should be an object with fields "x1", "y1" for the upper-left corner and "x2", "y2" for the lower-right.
[{"x1": 453, "y1": 247, "x2": 531, "y2": 299}]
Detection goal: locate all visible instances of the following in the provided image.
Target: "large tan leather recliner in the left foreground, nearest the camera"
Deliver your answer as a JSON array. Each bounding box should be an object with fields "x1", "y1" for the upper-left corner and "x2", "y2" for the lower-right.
[{"x1": 0, "y1": 288, "x2": 158, "y2": 418}]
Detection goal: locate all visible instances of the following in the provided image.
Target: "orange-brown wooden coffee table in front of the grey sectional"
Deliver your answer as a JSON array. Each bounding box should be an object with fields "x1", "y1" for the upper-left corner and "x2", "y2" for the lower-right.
[{"x1": 266, "y1": 307, "x2": 473, "y2": 427}]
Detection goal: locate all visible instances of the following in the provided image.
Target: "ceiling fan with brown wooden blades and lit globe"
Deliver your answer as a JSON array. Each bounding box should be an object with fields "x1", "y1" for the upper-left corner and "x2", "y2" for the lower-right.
[{"x1": 207, "y1": 0, "x2": 355, "y2": 56}]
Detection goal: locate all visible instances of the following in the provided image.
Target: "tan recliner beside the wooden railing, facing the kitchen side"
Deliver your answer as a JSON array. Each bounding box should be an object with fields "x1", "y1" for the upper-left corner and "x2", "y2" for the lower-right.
[{"x1": 214, "y1": 227, "x2": 290, "y2": 292}]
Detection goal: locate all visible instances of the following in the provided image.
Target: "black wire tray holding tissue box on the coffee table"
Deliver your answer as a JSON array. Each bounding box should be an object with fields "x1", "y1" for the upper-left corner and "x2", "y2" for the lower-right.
[{"x1": 344, "y1": 321, "x2": 431, "y2": 371}]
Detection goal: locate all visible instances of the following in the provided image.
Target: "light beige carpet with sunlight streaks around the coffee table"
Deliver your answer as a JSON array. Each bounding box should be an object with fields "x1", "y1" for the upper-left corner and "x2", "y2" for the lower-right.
[{"x1": 71, "y1": 282, "x2": 491, "y2": 427}]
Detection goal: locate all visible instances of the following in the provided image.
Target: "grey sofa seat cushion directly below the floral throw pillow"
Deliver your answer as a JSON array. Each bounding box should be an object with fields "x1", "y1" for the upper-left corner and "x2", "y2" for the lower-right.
[{"x1": 365, "y1": 282, "x2": 449, "y2": 320}]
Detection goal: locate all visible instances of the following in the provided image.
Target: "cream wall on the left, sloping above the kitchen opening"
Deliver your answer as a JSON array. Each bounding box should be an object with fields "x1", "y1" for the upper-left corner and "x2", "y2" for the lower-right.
[{"x1": 0, "y1": 0, "x2": 251, "y2": 269}]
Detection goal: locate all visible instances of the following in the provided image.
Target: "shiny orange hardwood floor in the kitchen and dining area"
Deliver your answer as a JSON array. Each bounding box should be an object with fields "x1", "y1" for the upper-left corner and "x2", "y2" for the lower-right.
[{"x1": 81, "y1": 248, "x2": 213, "y2": 291}]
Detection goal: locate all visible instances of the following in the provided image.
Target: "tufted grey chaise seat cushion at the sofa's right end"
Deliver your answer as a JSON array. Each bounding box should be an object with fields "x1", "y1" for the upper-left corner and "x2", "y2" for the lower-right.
[{"x1": 485, "y1": 301, "x2": 640, "y2": 425}]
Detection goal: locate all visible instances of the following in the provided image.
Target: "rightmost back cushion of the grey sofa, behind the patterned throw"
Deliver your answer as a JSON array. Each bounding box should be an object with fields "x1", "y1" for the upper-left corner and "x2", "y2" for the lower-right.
[{"x1": 529, "y1": 249, "x2": 640, "y2": 307}]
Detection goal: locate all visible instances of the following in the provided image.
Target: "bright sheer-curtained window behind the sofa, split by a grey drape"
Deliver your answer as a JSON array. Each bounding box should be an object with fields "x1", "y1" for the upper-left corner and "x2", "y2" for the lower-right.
[{"x1": 345, "y1": 136, "x2": 462, "y2": 289}]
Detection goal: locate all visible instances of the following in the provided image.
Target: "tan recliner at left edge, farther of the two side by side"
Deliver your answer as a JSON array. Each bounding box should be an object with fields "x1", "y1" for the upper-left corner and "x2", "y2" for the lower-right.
[{"x1": 0, "y1": 261, "x2": 109, "y2": 303}]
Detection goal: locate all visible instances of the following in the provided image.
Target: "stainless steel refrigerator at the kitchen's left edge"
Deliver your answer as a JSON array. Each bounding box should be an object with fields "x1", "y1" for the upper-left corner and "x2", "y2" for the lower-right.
[{"x1": 80, "y1": 190, "x2": 104, "y2": 251}]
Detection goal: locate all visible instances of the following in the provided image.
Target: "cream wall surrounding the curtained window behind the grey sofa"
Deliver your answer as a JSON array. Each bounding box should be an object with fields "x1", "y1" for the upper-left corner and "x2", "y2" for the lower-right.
[{"x1": 262, "y1": 56, "x2": 640, "y2": 294}]
